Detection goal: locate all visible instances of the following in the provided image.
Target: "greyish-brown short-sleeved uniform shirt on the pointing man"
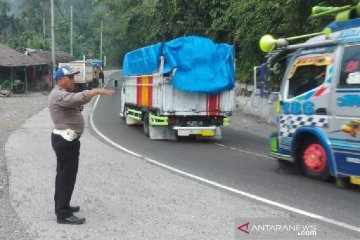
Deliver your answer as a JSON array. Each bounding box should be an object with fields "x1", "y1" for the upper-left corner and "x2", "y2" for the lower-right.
[{"x1": 48, "y1": 85, "x2": 90, "y2": 134}]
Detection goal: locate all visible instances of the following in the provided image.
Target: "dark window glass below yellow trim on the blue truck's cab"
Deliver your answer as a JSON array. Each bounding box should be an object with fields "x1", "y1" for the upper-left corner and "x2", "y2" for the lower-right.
[{"x1": 288, "y1": 65, "x2": 326, "y2": 98}]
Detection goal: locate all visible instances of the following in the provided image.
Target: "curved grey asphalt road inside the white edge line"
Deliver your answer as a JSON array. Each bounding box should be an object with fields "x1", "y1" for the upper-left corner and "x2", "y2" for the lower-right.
[{"x1": 93, "y1": 73, "x2": 360, "y2": 232}]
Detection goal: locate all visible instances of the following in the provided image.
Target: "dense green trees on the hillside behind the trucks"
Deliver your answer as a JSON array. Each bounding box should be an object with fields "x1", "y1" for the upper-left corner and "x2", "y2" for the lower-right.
[{"x1": 0, "y1": 0, "x2": 358, "y2": 81}]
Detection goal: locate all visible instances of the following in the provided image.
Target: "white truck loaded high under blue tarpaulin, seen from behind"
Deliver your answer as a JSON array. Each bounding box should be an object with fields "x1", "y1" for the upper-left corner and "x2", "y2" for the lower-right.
[{"x1": 120, "y1": 36, "x2": 235, "y2": 140}]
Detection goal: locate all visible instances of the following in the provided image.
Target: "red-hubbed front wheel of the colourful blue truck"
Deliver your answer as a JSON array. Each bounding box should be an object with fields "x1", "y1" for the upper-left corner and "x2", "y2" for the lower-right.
[{"x1": 301, "y1": 140, "x2": 330, "y2": 181}]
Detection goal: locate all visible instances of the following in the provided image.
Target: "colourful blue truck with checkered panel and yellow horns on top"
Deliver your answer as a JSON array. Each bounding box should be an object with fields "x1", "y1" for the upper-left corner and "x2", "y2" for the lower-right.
[{"x1": 260, "y1": 3, "x2": 360, "y2": 186}]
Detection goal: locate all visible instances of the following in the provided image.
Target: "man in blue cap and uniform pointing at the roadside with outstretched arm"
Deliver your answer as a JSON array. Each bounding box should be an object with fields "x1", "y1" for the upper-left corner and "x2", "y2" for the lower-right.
[{"x1": 49, "y1": 66, "x2": 113, "y2": 224}]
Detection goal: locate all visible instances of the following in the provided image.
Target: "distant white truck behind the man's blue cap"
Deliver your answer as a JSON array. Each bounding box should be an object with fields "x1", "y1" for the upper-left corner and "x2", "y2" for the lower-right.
[{"x1": 59, "y1": 60, "x2": 93, "y2": 91}]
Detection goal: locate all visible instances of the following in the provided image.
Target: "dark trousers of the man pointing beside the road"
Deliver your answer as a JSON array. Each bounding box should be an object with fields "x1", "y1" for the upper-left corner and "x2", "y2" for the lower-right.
[{"x1": 51, "y1": 133, "x2": 80, "y2": 219}]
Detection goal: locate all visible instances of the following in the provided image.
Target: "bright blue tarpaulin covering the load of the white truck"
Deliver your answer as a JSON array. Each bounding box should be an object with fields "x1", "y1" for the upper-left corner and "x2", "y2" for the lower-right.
[{"x1": 123, "y1": 36, "x2": 235, "y2": 94}]
